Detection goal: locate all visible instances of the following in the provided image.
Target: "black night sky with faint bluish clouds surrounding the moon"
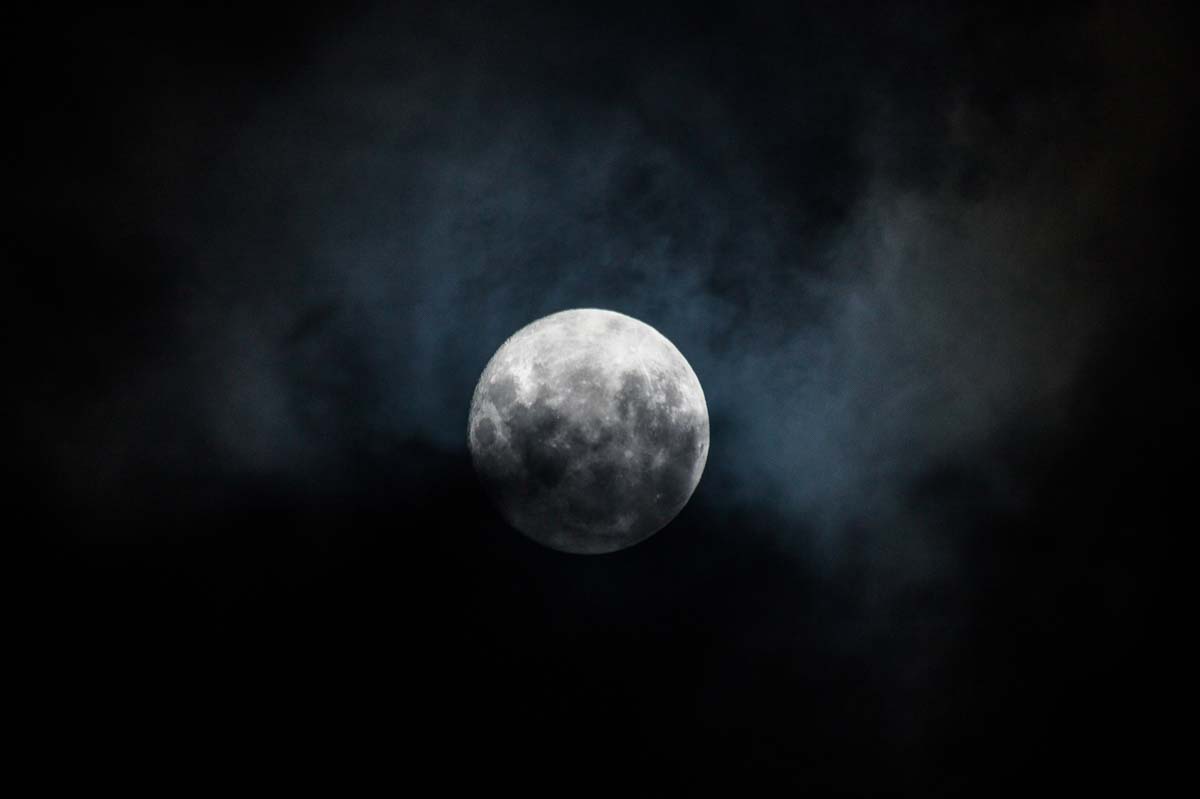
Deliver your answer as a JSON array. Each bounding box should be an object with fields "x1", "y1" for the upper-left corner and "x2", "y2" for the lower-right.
[{"x1": 14, "y1": 1, "x2": 1200, "y2": 795}]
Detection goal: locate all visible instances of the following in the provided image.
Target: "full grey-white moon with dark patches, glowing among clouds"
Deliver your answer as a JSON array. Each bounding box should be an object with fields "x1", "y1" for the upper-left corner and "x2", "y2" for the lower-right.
[{"x1": 468, "y1": 308, "x2": 708, "y2": 554}]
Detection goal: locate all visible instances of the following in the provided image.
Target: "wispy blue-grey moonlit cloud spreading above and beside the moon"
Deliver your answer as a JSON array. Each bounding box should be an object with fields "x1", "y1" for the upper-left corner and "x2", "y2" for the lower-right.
[{"x1": 35, "y1": 3, "x2": 1168, "y2": 554}]
